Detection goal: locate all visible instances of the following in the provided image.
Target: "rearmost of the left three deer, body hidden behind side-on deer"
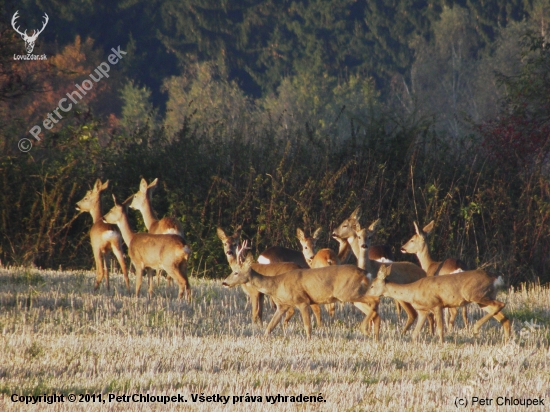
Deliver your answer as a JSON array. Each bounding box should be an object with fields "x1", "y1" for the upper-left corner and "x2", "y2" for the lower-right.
[{"x1": 130, "y1": 178, "x2": 191, "y2": 285}]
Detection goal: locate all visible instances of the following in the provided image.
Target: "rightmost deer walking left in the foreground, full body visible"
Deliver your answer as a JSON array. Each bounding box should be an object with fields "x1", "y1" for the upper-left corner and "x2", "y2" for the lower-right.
[{"x1": 368, "y1": 265, "x2": 510, "y2": 343}]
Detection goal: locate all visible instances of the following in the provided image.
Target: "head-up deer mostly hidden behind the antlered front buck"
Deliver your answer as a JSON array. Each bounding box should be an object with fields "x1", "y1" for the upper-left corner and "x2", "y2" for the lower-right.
[{"x1": 217, "y1": 226, "x2": 322, "y2": 326}]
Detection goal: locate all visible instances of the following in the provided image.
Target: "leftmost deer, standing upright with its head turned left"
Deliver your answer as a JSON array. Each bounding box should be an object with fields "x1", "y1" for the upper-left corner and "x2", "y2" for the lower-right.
[{"x1": 76, "y1": 179, "x2": 130, "y2": 291}]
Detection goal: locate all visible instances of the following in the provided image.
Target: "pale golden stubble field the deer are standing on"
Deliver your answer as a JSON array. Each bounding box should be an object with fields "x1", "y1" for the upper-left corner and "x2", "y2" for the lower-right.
[{"x1": 0, "y1": 268, "x2": 550, "y2": 411}]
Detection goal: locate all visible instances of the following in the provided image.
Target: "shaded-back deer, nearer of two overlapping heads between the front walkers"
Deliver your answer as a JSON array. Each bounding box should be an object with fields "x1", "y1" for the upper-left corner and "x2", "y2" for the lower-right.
[{"x1": 354, "y1": 220, "x2": 433, "y2": 333}]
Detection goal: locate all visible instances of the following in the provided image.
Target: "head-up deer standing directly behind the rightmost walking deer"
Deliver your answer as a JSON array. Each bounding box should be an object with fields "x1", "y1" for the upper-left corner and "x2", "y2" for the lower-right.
[{"x1": 401, "y1": 220, "x2": 468, "y2": 328}]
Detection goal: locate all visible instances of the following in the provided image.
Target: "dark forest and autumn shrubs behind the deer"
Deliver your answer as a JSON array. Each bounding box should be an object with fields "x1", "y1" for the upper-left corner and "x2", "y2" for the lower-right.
[{"x1": 0, "y1": 0, "x2": 550, "y2": 283}]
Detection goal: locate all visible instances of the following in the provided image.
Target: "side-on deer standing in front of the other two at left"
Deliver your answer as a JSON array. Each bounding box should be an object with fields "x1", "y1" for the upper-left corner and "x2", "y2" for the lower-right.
[{"x1": 103, "y1": 195, "x2": 191, "y2": 300}]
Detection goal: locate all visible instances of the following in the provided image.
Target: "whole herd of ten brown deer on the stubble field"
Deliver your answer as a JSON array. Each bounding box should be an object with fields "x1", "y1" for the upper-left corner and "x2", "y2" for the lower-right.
[{"x1": 77, "y1": 179, "x2": 511, "y2": 342}]
